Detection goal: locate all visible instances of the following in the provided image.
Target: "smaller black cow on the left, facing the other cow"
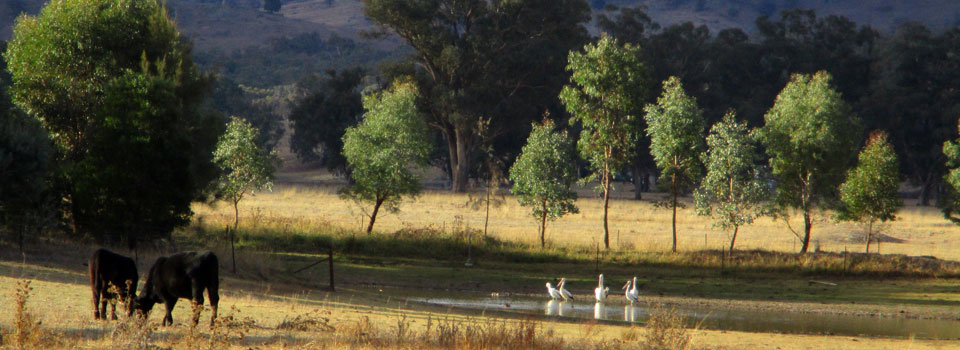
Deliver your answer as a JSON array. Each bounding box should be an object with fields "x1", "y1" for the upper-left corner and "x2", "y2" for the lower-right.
[{"x1": 89, "y1": 248, "x2": 139, "y2": 320}]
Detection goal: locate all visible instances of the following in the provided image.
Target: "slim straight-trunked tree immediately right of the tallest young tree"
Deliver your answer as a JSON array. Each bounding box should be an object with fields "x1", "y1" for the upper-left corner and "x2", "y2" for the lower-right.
[{"x1": 644, "y1": 77, "x2": 706, "y2": 252}]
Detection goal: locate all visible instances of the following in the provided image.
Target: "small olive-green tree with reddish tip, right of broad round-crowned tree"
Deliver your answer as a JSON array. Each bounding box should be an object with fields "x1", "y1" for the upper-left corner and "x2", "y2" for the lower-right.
[{"x1": 838, "y1": 131, "x2": 903, "y2": 253}]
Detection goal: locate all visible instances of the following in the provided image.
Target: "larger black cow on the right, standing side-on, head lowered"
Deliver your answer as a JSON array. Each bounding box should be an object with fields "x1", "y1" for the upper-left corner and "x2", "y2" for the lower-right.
[{"x1": 136, "y1": 252, "x2": 220, "y2": 326}]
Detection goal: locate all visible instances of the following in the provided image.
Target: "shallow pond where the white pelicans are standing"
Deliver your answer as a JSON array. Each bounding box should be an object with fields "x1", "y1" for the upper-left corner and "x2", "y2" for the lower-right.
[{"x1": 407, "y1": 295, "x2": 960, "y2": 339}]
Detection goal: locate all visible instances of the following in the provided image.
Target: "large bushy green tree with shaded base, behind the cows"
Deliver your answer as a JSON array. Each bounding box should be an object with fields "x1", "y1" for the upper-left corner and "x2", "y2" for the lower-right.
[{"x1": 5, "y1": 0, "x2": 220, "y2": 245}]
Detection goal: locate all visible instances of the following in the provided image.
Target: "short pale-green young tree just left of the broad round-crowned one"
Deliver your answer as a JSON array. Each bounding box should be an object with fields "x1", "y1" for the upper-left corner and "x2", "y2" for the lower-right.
[{"x1": 693, "y1": 111, "x2": 768, "y2": 251}]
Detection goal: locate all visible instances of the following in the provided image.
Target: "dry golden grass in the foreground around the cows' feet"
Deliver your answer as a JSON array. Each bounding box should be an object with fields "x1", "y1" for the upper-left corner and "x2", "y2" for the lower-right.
[{"x1": 0, "y1": 262, "x2": 960, "y2": 350}]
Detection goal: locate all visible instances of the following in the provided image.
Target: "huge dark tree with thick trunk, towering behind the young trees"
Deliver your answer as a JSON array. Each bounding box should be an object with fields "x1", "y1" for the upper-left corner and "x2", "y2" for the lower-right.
[{"x1": 364, "y1": 0, "x2": 590, "y2": 192}]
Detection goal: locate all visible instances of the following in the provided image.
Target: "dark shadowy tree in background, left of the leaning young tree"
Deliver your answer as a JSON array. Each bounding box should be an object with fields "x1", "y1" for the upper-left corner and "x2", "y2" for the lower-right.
[{"x1": 288, "y1": 68, "x2": 364, "y2": 171}]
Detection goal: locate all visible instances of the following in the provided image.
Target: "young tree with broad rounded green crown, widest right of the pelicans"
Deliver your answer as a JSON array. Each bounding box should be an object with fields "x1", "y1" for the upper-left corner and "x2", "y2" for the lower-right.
[{"x1": 756, "y1": 72, "x2": 860, "y2": 254}]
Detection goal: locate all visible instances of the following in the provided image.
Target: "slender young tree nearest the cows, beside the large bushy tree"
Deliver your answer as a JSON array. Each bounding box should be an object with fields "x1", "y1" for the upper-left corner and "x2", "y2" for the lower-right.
[{"x1": 213, "y1": 117, "x2": 280, "y2": 272}]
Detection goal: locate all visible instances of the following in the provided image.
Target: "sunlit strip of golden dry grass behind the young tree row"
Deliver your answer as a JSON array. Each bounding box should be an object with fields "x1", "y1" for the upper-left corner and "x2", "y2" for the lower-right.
[{"x1": 194, "y1": 172, "x2": 960, "y2": 260}]
